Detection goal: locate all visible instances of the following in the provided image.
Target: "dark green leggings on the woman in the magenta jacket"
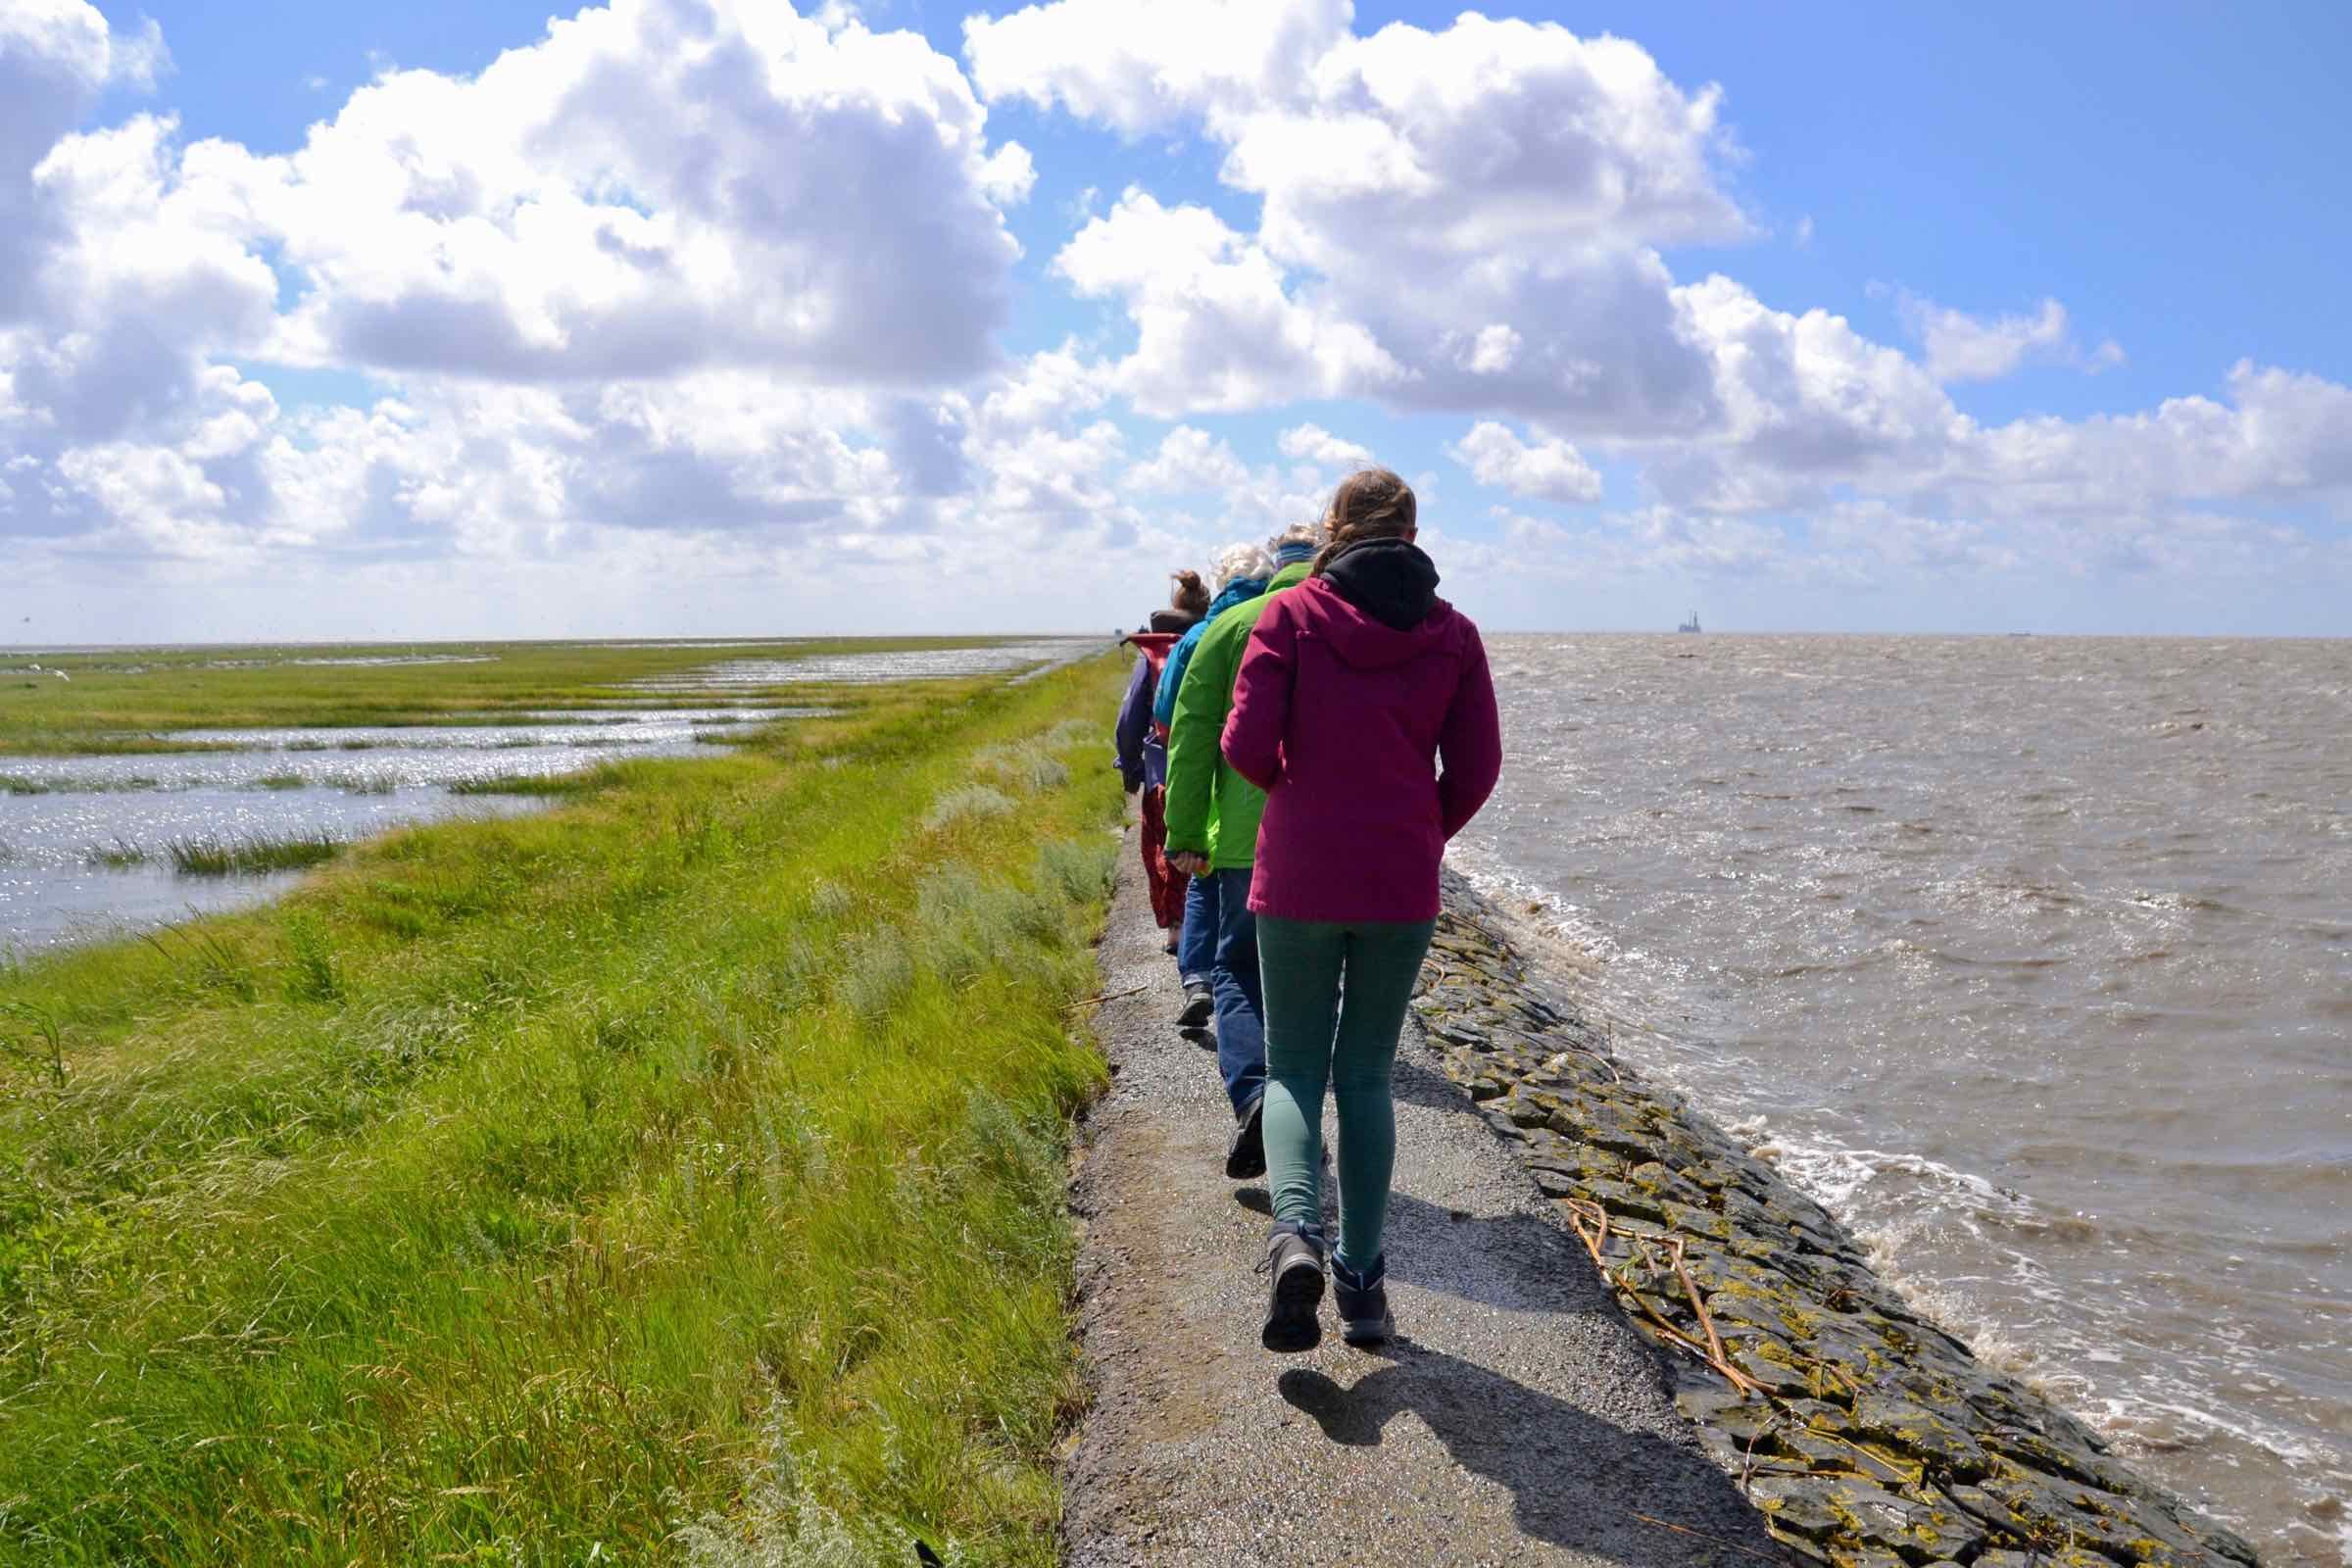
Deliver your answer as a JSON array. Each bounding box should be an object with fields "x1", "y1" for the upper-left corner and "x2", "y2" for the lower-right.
[{"x1": 1258, "y1": 914, "x2": 1437, "y2": 1272}]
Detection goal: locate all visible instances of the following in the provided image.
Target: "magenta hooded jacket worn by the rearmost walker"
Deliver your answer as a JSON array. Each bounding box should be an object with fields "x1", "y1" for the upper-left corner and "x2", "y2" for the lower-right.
[{"x1": 1223, "y1": 541, "x2": 1503, "y2": 921}]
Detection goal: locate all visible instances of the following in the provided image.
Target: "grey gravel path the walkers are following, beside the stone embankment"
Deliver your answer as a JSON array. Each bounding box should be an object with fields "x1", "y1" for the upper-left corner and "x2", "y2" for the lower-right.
[{"x1": 1065, "y1": 830, "x2": 1788, "y2": 1568}]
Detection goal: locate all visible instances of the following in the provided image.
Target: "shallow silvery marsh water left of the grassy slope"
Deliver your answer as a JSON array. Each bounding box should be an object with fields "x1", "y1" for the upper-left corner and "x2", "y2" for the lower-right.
[{"x1": 0, "y1": 706, "x2": 825, "y2": 953}]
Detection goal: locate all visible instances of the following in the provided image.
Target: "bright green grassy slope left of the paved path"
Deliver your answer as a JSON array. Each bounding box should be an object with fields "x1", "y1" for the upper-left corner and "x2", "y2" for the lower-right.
[{"x1": 0, "y1": 659, "x2": 1124, "y2": 1566}]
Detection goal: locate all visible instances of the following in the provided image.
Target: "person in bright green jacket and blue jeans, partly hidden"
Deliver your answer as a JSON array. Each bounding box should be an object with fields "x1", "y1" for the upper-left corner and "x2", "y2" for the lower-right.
[{"x1": 1166, "y1": 524, "x2": 1319, "y2": 1180}]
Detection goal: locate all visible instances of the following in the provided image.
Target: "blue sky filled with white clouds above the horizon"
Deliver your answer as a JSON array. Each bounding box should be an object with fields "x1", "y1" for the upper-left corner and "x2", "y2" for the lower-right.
[{"x1": 0, "y1": 0, "x2": 2352, "y2": 644}]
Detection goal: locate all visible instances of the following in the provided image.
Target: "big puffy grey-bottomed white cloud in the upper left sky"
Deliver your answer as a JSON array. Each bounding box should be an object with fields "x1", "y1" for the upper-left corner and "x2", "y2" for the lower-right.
[{"x1": 139, "y1": 0, "x2": 1035, "y2": 385}]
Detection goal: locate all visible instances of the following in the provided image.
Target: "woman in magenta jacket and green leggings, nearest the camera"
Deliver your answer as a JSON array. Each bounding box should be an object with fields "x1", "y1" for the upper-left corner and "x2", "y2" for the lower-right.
[{"x1": 1223, "y1": 467, "x2": 1503, "y2": 1349}]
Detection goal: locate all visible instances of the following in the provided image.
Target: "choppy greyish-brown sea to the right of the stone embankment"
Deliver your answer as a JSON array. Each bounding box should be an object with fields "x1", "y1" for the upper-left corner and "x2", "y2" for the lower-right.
[{"x1": 1456, "y1": 635, "x2": 2352, "y2": 1568}]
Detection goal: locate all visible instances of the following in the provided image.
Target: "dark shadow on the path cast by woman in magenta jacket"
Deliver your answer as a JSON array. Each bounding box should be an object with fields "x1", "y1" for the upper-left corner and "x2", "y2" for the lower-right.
[{"x1": 1277, "y1": 1340, "x2": 1794, "y2": 1568}]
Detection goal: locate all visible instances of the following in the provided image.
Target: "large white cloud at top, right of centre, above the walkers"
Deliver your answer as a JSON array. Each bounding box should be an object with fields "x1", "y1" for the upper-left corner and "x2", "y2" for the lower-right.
[{"x1": 966, "y1": 0, "x2": 1747, "y2": 432}]
